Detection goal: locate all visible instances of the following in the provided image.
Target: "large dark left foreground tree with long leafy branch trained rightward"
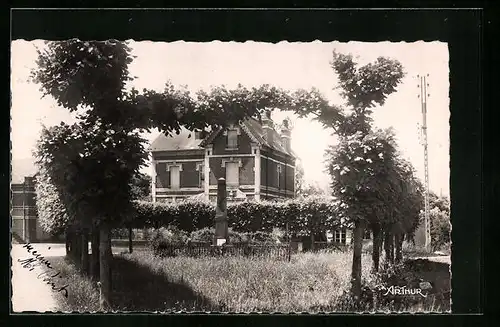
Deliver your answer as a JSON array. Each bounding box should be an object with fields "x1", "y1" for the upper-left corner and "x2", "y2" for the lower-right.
[{"x1": 32, "y1": 39, "x2": 336, "y2": 309}]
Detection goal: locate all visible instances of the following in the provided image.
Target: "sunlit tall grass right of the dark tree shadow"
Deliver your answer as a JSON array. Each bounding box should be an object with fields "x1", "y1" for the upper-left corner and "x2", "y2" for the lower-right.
[{"x1": 125, "y1": 253, "x2": 370, "y2": 312}]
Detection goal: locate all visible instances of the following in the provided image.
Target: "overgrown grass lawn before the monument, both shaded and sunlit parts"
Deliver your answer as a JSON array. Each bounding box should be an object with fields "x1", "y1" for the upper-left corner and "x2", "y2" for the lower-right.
[{"x1": 47, "y1": 251, "x2": 449, "y2": 312}]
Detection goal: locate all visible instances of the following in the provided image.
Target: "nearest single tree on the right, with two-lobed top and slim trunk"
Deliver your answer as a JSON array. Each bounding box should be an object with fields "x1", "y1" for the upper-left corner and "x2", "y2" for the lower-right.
[{"x1": 316, "y1": 51, "x2": 404, "y2": 299}]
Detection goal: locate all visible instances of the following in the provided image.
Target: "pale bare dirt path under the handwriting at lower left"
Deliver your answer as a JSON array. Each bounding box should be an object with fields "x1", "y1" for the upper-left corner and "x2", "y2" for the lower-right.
[{"x1": 11, "y1": 244, "x2": 65, "y2": 312}]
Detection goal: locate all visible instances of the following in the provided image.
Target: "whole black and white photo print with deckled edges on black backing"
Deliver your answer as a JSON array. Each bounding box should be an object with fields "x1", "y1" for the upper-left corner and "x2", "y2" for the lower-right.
[{"x1": 11, "y1": 38, "x2": 452, "y2": 313}]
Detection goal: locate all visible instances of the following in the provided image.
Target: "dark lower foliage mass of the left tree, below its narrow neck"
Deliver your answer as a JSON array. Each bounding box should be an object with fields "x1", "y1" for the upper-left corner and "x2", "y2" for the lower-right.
[{"x1": 35, "y1": 124, "x2": 146, "y2": 232}]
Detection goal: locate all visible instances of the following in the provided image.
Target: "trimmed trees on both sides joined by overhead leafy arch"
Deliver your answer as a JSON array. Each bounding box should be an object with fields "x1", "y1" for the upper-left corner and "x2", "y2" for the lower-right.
[{"x1": 33, "y1": 40, "x2": 421, "y2": 309}]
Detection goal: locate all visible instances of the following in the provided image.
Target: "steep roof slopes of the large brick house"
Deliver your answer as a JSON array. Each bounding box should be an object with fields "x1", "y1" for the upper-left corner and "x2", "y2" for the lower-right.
[{"x1": 149, "y1": 118, "x2": 296, "y2": 157}]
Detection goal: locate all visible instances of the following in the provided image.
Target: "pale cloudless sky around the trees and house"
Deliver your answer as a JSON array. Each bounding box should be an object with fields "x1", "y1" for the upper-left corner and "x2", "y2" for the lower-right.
[{"x1": 11, "y1": 40, "x2": 450, "y2": 195}]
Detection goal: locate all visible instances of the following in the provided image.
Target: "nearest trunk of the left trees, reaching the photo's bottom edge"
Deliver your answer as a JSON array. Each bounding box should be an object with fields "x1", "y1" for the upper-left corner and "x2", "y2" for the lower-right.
[{"x1": 99, "y1": 223, "x2": 113, "y2": 311}]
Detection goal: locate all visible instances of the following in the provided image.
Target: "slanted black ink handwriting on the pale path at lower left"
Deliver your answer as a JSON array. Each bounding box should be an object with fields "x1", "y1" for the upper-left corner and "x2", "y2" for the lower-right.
[{"x1": 17, "y1": 243, "x2": 69, "y2": 297}]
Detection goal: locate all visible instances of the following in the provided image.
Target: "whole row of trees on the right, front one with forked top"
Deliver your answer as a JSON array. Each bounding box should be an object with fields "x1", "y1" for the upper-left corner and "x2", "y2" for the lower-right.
[{"x1": 292, "y1": 52, "x2": 423, "y2": 299}]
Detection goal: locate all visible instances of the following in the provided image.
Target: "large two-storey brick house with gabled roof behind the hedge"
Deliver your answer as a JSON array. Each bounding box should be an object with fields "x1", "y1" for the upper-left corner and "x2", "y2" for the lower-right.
[{"x1": 149, "y1": 115, "x2": 296, "y2": 202}]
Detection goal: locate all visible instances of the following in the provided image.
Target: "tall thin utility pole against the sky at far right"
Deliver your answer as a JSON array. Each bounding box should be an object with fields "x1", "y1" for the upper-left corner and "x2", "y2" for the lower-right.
[{"x1": 417, "y1": 74, "x2": 431, "y2": 252}]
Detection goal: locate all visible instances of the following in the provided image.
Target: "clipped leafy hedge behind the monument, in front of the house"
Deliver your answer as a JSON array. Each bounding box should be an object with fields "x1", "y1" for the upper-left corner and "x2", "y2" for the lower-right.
[{"x1": 132, "y1": 197, "x2": 341, "y2": 235}]
